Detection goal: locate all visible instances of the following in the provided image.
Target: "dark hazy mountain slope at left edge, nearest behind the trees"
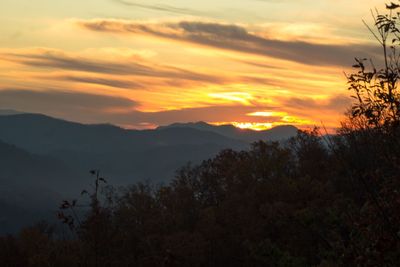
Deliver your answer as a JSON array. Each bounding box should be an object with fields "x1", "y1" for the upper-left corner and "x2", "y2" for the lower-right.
[{"x1": 0, "y1": 141, "x2": 78, "y2": 234}]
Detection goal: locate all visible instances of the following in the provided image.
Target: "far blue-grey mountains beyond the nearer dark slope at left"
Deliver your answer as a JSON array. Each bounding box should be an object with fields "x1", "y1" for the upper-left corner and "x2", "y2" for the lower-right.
[{"x1": 0, "y1": 114, "x2": 297, "y2": 184}]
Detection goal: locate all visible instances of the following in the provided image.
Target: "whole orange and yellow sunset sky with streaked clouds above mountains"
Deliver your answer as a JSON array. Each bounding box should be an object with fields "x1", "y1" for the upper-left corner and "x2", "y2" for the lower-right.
[{"x1": 0, "y1": 0, "x2": 385, "y2": 130}]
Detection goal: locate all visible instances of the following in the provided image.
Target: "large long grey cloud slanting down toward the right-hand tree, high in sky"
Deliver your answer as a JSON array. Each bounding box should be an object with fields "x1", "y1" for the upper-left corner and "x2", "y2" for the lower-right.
[{"x1": 80, "y1": 20, "x2": 379, "y2": 67}]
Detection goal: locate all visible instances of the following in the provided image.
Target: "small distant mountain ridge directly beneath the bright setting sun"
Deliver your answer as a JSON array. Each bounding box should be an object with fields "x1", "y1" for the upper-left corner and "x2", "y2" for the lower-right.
[{"x1": 158, "y1": 121, "x2": 298, "y2": 142}]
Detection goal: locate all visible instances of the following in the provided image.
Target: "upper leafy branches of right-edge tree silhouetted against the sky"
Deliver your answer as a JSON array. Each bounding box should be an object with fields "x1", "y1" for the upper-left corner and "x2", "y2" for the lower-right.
[{"x1": 347, "y1": 0, "x2": 400, "y2": 127}]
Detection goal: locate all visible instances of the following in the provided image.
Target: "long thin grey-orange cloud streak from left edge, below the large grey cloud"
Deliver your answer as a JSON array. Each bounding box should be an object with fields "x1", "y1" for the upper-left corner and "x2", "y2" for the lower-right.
[{"x1": 0, "y1": 49, "x2": 290, "y2": 90}]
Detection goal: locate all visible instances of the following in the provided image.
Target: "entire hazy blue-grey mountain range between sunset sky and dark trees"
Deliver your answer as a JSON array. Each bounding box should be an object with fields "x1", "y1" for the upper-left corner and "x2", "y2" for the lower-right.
[{"x1": 0, "y1": 110, "x2": 297, "y2": 234}]
